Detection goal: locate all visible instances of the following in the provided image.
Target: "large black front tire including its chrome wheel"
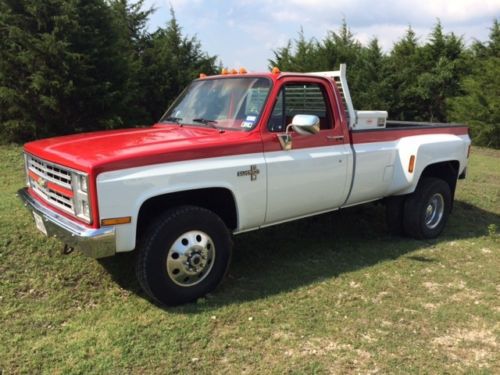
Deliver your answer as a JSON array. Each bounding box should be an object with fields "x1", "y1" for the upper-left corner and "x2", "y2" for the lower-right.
[{"x1": 136, "y1": 206, "x2": 232, "y2": 306}]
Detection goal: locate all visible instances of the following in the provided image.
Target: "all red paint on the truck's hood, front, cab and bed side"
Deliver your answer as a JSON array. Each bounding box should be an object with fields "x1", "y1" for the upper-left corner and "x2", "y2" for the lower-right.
[{"x1": 24, "y1": 73, "x2": 467, "y2": 228}]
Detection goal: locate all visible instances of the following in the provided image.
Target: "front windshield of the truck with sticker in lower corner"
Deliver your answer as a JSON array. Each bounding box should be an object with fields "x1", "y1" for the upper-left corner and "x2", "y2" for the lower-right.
[{"x1": 160, "y1": 77, "x2": 271, "y2": 131}]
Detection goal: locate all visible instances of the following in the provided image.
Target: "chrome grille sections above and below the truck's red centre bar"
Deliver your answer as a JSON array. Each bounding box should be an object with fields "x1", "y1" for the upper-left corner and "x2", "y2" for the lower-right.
[{"x1": 26, "y1": 155, "x2": 75, "y2": 214}]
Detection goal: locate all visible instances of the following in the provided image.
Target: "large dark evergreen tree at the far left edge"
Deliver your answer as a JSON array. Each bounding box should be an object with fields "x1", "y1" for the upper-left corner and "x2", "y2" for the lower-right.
[{"x1": 0, "y1": 0, "x2": 131, "y2": 141}]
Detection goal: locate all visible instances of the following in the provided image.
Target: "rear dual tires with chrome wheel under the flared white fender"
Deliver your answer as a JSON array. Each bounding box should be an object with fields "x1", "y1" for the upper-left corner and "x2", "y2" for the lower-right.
[{"x1": 403, "y1": 177, "x2": 451, "y2": 239}]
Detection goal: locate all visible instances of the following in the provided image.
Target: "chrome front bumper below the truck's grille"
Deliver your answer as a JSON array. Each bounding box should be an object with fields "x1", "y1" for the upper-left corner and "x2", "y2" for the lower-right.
[{"x1": 17, "y1": 188, "x2": 116, "y2": 258}]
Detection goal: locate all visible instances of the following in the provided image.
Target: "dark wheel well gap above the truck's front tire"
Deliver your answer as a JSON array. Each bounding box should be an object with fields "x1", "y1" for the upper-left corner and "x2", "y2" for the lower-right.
[{"x1": 137, "y1": 188, "x2": 238, "y2": 242}]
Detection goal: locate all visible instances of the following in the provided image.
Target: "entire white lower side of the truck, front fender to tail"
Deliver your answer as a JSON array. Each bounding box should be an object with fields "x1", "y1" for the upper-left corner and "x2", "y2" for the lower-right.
[{"x1": 97, "y1": 134, "x2": 470, "y2": 252}]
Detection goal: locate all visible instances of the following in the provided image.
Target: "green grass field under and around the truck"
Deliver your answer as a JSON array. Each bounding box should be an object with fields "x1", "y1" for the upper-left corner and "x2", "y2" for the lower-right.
[{"x1": 0, "y1": 146, "x2": 500, "y2": 374}]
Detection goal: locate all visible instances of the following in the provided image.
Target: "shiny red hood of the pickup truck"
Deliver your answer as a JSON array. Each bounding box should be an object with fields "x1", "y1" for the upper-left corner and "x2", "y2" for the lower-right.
[{"x1": 24, "y1": 125, "x2": 262, "y2": 174}]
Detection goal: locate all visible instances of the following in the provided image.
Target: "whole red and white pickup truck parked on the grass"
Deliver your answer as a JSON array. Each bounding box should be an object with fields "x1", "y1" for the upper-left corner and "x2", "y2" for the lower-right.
[{"x1": 18, "y1": 66, "x2": 470, "y2": 305}]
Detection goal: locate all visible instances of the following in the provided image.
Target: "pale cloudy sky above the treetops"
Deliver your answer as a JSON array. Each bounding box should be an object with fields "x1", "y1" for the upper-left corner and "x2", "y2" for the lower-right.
[{"x1": 146, "y1": 0, "x2": 500, "y2": 71}]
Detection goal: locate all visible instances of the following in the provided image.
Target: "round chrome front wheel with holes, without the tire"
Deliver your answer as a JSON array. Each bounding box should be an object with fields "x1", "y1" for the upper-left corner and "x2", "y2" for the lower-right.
[{"x1": 167, "y1": 230, "x2": 215, "y2": 287}]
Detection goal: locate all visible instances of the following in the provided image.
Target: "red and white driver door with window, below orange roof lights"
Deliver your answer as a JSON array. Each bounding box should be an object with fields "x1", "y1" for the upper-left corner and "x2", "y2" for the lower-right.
[{"x1": 262, "y1": 77, "x2": 353, "y2": 224}]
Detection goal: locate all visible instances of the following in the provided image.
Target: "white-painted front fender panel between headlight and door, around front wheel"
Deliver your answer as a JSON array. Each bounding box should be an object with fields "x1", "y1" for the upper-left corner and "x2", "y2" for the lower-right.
[{"x1": 97, "y1": 153, "x2": 267, "y2": 251}]
